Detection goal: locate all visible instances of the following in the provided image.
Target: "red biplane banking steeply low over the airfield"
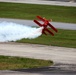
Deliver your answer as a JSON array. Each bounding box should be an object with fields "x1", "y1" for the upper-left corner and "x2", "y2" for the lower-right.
[{"x1": 34, "y1": 16, "x2": 58, "y2": 36}]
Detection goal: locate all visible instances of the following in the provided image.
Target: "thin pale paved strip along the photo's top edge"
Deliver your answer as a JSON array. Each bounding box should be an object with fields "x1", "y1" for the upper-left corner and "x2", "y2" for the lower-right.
[{"x1": 0, "y1": 0, "x2": 76, "y2": 7}]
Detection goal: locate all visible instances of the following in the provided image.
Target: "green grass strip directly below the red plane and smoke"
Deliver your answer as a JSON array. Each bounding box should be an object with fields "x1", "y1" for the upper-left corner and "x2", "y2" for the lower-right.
[{"x1": 17, "y1": 29, "x2": 76, "y2": 48}]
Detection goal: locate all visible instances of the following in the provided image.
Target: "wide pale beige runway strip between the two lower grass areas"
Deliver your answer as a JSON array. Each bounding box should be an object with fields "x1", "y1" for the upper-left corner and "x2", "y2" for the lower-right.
[{"x1": 0, "y1": 42, "x2": 76, "y2": 64}]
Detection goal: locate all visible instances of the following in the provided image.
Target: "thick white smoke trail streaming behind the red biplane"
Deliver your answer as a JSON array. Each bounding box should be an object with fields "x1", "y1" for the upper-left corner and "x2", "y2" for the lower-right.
[{"x1": 0, "y1": 22, "x2": 43, "y2": 42}]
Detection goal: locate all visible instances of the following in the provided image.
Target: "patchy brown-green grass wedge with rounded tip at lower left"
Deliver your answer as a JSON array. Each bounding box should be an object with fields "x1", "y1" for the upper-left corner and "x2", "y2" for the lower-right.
[{"x1": 0, "y1": 55, "x2": 53, "y2": 70}]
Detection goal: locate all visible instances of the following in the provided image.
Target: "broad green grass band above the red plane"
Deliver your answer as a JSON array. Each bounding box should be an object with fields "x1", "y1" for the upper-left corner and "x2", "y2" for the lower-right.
[{"x1": 0, "y1": 2, "x2": 76, "y2": 23}]
